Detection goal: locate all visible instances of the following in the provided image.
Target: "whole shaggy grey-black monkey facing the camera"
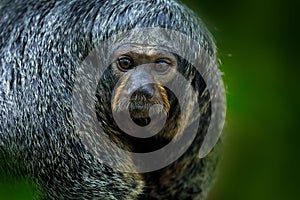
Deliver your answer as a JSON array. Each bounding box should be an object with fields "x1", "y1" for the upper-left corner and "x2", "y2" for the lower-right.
[{"x1": 0, "y1": 0, "x2": 225, "y2": 200}]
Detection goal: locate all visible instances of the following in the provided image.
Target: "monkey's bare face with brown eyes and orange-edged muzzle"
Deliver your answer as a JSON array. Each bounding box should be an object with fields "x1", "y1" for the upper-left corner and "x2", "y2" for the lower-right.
[{"x1": 111, "y1": 44, "x2": 178, "y2": 130}]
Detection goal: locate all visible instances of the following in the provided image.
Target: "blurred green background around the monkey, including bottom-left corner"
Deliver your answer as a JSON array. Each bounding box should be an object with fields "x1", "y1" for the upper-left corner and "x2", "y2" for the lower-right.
[{"x1": 0, "y1": 0, "x2": 300, "y2": 200}]
